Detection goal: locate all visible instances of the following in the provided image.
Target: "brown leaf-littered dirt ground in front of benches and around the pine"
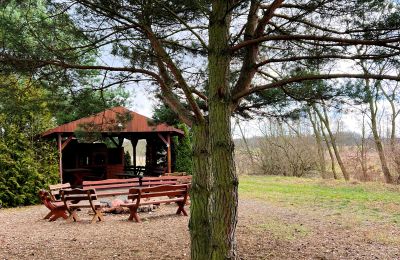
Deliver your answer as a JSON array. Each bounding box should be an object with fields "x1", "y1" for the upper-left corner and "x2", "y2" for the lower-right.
[{"x1": 0, "y1": 199, "x2": 400, "y2": 259}]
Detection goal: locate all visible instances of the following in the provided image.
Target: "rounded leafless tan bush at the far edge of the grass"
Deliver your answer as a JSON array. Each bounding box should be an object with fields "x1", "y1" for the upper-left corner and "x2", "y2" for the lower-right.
[{"x1": 236, "y1": 121, "x2": 319, "y2": 177}]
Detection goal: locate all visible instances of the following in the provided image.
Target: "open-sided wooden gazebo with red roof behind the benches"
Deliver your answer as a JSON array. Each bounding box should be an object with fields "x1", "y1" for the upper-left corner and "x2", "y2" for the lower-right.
[{"x1": 42, "y1": 107, "x2": 184, "y2": 182}]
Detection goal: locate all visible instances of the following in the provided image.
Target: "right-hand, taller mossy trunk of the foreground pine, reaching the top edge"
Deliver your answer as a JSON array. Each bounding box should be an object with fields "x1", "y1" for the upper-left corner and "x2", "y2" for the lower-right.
[{"x1": 208, "y1": 0, "x2": 238, "y2": 260}]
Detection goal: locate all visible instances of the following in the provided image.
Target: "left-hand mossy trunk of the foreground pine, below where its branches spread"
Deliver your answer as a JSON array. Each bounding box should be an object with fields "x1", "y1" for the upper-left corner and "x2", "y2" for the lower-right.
[{"x1": 189, "y1": 123, "x2": 211, "y2": 259}]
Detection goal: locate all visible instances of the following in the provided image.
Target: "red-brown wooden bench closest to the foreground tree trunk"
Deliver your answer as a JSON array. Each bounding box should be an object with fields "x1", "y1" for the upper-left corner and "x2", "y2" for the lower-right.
[{"x1": 121, "y1": 184, "x2": 189, "y2": 222}]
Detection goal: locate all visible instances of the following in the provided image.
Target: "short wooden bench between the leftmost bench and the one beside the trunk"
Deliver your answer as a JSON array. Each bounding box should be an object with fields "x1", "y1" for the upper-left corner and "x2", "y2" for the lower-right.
[{"x1": 61, "y1": 189, "x2": 104, "y2": 223}]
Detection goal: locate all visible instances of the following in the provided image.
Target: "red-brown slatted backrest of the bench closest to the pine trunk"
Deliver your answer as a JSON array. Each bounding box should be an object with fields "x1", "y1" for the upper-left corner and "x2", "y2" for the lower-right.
[{"x1": 128, "y1": 184, "x2": 189, "y2": 202}]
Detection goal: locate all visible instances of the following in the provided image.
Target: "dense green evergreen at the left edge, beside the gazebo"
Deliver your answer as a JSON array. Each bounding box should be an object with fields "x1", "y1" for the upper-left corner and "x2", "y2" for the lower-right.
[{"x1": 0, "y1": 76, "x2": 58, "y2": 207}]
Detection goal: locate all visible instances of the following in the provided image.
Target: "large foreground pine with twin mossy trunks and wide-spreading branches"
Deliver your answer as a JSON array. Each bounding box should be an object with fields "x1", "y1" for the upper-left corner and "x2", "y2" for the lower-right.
[{"x1": 0, "y1": 0, "x2": 400, "y2": 259}]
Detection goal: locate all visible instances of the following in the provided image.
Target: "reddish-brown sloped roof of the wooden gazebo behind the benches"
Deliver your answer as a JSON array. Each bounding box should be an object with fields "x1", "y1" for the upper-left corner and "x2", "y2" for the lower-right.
[{"x1": 42, "y1": 107, "x2": 184, "y2": 138}]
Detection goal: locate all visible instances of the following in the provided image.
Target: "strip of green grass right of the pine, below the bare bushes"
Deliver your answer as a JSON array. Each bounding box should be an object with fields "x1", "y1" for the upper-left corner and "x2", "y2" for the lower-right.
[{"x1": 239, "y1": 176, "x2": 400, "y2": 226}]
